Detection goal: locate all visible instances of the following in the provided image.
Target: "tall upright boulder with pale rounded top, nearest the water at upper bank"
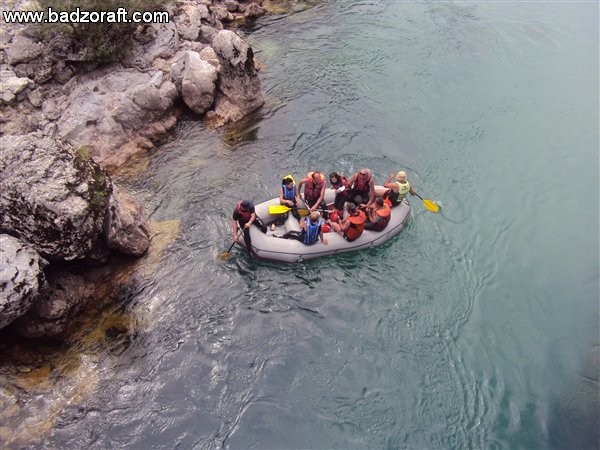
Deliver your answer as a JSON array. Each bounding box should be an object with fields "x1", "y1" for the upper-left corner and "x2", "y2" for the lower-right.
[{"x1": 212, "y1": 30, "x2": 264, "y2": 124}]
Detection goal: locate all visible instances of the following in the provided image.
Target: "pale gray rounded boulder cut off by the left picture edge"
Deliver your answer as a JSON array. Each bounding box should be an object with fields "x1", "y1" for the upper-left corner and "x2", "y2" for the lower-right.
[{"x1": 0, "y1": 234, "x2": 47, "y2": 328}]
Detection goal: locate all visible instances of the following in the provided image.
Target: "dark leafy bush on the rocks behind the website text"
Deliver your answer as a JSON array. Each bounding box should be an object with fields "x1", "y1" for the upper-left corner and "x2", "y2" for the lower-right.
[{"x1": 37, "y1": 0, "x2": 171, "y2": 63}]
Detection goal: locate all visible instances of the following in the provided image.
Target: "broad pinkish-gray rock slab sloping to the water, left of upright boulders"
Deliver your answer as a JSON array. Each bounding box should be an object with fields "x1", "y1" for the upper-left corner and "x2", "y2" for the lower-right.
[{"x1": 55, "y1": 67, "x2": 178, "y2": 169}]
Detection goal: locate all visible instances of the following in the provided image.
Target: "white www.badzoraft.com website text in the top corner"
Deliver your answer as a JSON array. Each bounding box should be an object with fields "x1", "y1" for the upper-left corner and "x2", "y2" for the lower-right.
[{"x1": 2, "y1": 7, "x2": 169, "y2": 23}]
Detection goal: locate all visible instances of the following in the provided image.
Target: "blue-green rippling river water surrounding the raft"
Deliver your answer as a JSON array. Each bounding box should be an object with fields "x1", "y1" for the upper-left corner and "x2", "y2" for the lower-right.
[{"x1": 9, "y1": 0, "x2": 600, "y2": 449}]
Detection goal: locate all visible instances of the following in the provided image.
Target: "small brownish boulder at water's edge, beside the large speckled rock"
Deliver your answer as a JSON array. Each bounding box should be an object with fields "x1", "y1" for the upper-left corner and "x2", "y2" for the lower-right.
[{"x1": 104, "y1": 186, "x2": 150, "y2": 256}]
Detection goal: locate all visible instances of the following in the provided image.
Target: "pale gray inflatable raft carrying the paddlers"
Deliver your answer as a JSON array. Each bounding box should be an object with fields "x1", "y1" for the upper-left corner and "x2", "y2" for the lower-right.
[{"x1": 238, "y1": 188, "x2": 410, "y2": 263}]
